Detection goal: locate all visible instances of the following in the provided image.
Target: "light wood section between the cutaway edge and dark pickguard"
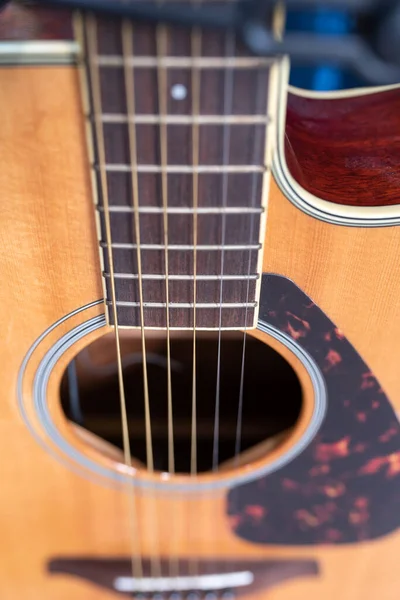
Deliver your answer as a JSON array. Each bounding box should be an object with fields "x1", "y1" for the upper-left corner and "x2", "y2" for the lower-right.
[{"x1": 263, "y1": 178, "x2": 400, "y2": 411}]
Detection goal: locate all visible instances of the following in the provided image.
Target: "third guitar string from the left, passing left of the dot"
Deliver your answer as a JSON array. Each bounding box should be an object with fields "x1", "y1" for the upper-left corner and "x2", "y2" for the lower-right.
[{"x1": 156, "y1": 25, "x2": 179, "y2": 577}]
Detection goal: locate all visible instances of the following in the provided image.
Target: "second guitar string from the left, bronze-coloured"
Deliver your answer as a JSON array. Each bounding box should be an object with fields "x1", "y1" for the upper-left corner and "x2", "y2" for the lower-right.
[{"x1": 121, "y1": 20, "x2": 161, "y2": 578}]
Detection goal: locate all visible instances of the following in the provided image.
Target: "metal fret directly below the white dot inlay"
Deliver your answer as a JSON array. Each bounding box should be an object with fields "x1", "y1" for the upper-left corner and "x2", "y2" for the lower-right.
[{"x1": 98, "y1": 113, "x2": 270, "y2": 125}]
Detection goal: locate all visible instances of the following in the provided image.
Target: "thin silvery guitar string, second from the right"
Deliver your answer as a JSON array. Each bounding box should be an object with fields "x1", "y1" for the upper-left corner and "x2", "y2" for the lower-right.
[{"x1": 212, "y1": 33, "x2": 235, "y2": 472}]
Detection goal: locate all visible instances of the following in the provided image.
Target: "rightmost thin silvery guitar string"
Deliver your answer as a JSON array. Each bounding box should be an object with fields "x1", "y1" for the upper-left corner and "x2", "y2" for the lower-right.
[{"x1": 234, "y1": 64, "x2": 268, "y2": 465}]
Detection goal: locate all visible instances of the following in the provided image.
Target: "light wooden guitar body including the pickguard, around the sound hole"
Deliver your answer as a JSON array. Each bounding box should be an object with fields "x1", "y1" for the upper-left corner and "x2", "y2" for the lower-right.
[{"x1": 0, "y1": 4, "x2": 400, "y2": 600}]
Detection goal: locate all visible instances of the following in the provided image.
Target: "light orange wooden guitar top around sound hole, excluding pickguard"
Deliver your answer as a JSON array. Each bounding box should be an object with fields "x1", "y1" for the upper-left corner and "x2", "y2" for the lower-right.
[{"x1": 0, "y1": 67, "x2": 400, "y2": 600}]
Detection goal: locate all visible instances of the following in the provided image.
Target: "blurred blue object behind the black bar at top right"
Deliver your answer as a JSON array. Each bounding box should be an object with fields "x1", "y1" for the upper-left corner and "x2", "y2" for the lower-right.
[{"x1": 286, "y1": 7, "x2": 365, "y2": 91}]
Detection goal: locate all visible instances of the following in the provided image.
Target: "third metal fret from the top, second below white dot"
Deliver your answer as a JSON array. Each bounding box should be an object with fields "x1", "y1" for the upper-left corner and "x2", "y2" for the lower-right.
[{"x1": 96, "y1": 163, "x2": 266, "y2": 173}]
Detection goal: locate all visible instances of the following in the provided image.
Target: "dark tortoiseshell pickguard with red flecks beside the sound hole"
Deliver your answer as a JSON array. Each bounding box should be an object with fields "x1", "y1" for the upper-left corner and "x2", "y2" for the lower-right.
[{"x1": 228, "y1": 275, "x2": 400, "y2": 545}]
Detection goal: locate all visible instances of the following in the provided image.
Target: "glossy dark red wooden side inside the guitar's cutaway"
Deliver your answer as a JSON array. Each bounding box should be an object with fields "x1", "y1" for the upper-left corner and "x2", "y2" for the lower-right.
[{"x1": 285, "y1": 89, "x2": 400, "y2": 206}]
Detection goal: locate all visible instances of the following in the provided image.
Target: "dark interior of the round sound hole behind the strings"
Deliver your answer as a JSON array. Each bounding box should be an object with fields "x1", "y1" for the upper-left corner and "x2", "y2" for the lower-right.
[{"x1": 61, "y1": 333, "x2": 301, "y2": 473}]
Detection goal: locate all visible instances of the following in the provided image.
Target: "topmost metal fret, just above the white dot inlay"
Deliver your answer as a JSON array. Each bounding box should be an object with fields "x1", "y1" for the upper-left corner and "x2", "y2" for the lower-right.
[{"x1": 93, "y1": 54, "x2": 275, "y2": 69}]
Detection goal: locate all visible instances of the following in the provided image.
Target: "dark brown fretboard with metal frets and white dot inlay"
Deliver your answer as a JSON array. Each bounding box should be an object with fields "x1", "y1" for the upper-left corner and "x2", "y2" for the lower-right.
[{"x1": 79, "y1": 3, "x2": 282, "y2": 329}]
